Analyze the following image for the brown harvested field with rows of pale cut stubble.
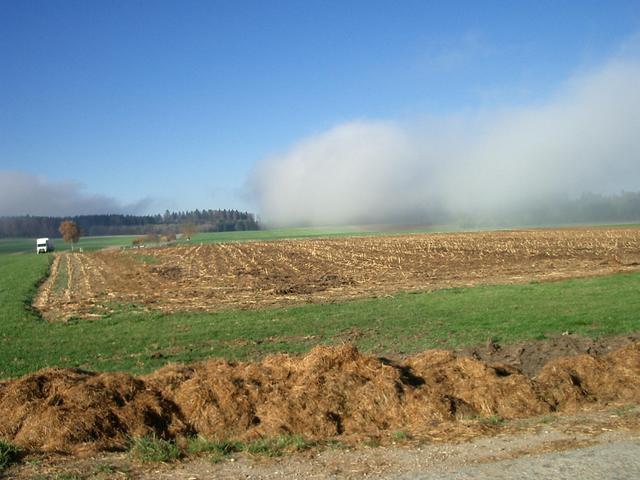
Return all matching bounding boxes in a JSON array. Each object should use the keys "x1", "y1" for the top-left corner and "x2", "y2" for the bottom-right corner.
[{"x1": 34, "y1": 228, "x2": 640, "y2": 321}]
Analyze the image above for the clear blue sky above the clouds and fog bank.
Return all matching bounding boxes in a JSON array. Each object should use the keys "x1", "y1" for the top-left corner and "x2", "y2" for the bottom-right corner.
[{"x1": 0, "y1": 0, "x2": 640, "y2": 218}]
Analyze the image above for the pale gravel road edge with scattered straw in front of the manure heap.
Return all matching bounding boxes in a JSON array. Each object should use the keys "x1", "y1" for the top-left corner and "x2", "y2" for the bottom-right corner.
[{"x1": 8, "y1": 405, "x2": 640, "y2": 480}]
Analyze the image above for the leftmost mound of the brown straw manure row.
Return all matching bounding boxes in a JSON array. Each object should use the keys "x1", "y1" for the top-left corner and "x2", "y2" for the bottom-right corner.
[{"x1": 0, "y1": 368, "x2": 188, "y2": 451}]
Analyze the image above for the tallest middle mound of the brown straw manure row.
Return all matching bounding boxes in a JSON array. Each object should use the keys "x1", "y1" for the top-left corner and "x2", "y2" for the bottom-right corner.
[{"x1": 147, "y1": 345, "x2": 404, "y2": 438}]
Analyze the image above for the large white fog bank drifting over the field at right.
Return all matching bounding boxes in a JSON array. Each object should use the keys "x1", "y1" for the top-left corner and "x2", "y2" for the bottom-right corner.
[{"x1": 250, "y1": 59, "x2": 640, "y2": 225}]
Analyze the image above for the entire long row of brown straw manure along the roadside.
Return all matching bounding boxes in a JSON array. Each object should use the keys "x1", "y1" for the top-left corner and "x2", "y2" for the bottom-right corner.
[{"x1": 0, "y1": 342, "x2": 640, "y2": 452}]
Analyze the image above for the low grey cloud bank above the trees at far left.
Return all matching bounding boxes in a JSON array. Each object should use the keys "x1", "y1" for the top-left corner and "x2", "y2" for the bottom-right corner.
[{"x1": 0, "y1": 170, "x2": 151, "y2": 217}]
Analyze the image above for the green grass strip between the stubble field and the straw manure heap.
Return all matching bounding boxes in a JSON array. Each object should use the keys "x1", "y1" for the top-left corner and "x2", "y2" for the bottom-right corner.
[{"x1": 0, "y1": 233, "x2": 640, "y2": 378}]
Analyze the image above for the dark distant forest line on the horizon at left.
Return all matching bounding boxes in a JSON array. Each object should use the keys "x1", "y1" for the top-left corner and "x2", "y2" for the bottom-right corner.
[{"x1": 0, "y1": 209, "x2": 260, "y2": 238}]
